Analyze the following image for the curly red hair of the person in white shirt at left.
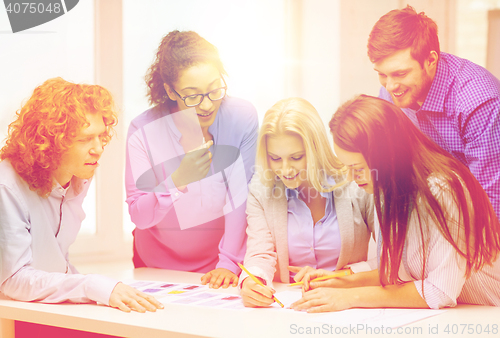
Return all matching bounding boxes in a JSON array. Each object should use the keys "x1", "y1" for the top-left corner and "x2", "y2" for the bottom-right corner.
[{"x1": 0, "y1": 77, "x2": 118, "y2": 196}]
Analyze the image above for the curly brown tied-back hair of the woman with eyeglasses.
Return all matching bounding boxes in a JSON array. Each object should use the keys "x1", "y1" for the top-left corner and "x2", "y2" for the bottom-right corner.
[{"x1": 146, "y1": 30, "x2": 227, "y2": 105}]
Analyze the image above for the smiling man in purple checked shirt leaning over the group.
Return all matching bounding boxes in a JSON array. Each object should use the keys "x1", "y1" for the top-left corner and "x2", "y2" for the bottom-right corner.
[{"x1": 368, "y1": 6, "x2": 500, "y2": 222}]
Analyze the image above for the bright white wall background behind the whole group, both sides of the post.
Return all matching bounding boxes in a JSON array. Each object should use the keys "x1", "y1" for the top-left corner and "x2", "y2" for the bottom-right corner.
[{"x1": 0, "y1": 0, "x2": 500, "y2": 264}]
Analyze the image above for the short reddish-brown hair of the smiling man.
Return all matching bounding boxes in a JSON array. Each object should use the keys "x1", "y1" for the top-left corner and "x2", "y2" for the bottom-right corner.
[{"x1": 368, "y1": 5, "x2": 440, "y2": 67}]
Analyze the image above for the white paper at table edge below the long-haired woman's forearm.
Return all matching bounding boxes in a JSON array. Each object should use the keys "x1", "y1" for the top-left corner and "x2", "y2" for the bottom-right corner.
[{"x1": 311, "y1": 309, "x2": 447, "y2": 328}]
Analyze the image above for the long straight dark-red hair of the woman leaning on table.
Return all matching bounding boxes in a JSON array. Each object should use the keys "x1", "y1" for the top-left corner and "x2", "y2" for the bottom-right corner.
[{"x1": 329, "y1": 95, "x2": 500, "y2": 285}]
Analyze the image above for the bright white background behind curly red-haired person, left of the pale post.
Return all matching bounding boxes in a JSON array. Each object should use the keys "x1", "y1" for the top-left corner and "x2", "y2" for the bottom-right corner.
[{"x1": 0, "y1": 1, "x2": 95, "y2": 233}]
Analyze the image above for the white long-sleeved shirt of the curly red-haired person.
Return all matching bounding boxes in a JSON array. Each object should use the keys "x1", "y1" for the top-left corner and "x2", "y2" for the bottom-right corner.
[{"x1": 0, "y1": 160, "x2": 118, "y2": 305}]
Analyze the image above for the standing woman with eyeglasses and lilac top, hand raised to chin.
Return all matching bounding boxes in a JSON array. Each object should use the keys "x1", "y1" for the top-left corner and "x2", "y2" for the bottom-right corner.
[{"x1": 125, "y1": 31, "x2": 258, "y2": 288}]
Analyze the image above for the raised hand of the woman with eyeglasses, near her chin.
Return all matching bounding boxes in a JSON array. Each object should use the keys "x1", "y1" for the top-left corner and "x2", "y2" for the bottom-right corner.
[{"x1": 172, "y1": 140, "x2": 214, "y2": 189}]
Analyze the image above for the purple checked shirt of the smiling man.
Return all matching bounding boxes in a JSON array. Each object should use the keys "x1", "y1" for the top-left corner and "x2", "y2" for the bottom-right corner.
[{"x1": 379, "y1": 53, "x2": 500, "y2": 219}]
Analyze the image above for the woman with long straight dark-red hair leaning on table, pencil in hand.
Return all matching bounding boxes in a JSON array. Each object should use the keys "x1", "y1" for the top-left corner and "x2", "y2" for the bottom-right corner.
[{"x1": 294, "y1": 95, "x2": 500, "y2": 312}]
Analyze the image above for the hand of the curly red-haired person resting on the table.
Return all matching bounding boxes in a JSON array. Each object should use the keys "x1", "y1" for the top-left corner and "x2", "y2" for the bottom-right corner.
[{"x1": 109, "y1": 282, "x2": 163, "y2": 312}]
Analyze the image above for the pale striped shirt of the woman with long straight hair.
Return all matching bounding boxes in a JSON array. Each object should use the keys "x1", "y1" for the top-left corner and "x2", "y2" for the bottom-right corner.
[{"x1": 399, "y1": 179, "x2": 500, "y2": 309}]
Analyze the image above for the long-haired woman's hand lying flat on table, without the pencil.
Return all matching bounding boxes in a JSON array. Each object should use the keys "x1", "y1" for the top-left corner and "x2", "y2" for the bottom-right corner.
[{"x1": 290, "y1": 288, "x2": 356, "y2": 313}]
